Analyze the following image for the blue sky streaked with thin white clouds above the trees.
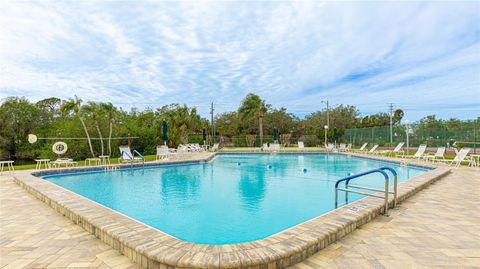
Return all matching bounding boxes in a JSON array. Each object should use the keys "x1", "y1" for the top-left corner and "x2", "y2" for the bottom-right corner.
[{"x1": 0, "y1": 1, "x2": 480, "y2": 120}]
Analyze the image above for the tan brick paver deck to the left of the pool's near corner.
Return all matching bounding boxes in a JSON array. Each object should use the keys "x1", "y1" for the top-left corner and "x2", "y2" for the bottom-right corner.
[{"x1": 0, "y1": 176, "x2": 139, "y2": 269}]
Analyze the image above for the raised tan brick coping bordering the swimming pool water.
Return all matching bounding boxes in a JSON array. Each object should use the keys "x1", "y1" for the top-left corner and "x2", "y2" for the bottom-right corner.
[{"x1": 14, "y1": 153, "x2": 450, "y2": 268}]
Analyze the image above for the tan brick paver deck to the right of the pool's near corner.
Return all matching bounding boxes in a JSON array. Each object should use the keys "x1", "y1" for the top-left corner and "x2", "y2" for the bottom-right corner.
[{"x1": 291, "y1": 168, "x2": 480, "y2": 269}]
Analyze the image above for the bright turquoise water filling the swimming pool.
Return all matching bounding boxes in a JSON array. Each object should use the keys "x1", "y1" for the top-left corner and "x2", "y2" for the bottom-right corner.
[{"x1": 45, "y1": 154, "x2": 426, "y2": 244}]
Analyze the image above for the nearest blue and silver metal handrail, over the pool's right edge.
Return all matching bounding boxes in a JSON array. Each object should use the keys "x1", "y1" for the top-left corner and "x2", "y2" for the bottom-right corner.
[{"x1": 335, "y1": 167, "x2": 396, "y2": 214}]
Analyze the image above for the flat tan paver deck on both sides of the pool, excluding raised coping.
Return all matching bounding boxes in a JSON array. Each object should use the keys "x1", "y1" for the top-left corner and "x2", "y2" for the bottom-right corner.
[{"x1": 0, "y1": 162, "x2": 480, "y2": 269}]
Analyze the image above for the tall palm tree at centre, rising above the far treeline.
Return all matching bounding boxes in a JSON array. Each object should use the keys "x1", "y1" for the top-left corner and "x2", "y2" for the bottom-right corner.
[{"x1": 238, "y1": 93, "x2": 269, "y2": 145}]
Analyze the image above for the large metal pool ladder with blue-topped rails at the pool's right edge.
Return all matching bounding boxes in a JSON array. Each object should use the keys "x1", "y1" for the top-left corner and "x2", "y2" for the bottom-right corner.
[{"x1": 335, "y1": 166, "x2": 398, "y2": 215}]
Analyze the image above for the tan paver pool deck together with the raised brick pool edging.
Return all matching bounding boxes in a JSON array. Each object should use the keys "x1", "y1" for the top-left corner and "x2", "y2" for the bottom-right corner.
[{"x1": 0, "y1": 152, "x2": 480, "y2": 268}]
